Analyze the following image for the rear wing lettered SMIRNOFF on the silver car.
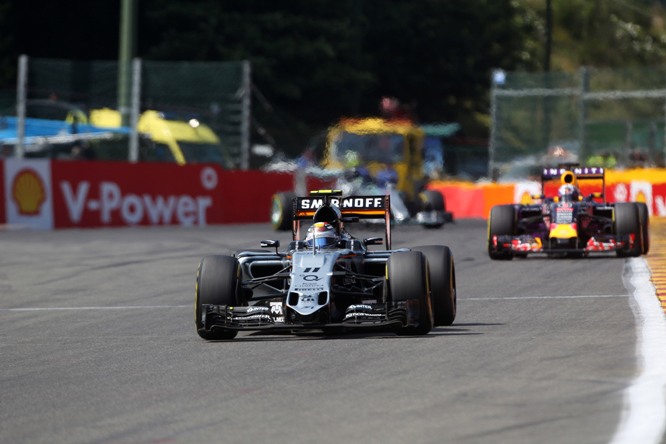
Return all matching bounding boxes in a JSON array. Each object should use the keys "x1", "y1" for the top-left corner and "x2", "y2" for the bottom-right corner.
[{"x1": 292, "y1": 190, "x2": 391, "y2": 250}]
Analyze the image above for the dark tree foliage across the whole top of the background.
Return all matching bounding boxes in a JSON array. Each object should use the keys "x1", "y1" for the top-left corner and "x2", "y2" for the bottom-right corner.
[{"x1": 0, "y1": 0, "x2": 666, "y2": 143}]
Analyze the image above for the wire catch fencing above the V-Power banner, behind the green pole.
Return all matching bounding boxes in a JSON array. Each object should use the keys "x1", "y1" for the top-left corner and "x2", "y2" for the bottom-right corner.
[{"x1": 11, "y1": 56, "x2": 252, "y2": 169}]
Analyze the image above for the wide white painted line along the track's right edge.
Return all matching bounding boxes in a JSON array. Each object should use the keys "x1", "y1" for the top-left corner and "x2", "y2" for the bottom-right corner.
[{"x1": 610, "y1": 258, "x2": 666, "y2": 444}]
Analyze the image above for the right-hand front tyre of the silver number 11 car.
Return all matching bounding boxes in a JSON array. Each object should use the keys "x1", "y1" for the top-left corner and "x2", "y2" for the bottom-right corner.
[{"x1": 387, "y1": 251, "x2": 434, "y2": 335}]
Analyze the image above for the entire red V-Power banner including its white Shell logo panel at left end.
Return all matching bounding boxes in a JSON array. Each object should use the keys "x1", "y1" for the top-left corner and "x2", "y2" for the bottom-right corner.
[{"x1": 0, "y1": 159, "x2": 293, "y2": 229}]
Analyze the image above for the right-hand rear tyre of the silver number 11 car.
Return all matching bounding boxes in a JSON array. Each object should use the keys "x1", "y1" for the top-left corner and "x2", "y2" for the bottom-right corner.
[{"x1": 412, "y1": 245, "x2": 457, "y2": 326}]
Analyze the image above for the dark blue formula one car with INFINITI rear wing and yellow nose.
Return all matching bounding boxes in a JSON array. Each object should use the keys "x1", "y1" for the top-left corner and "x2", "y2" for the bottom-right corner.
[{"x1": 488, "y1": 165, "x2": 650, "y2": 260}]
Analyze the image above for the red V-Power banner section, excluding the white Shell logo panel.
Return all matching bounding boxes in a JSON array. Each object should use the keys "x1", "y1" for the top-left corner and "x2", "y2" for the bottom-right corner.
[{"x1": 52, "y1": 161, "x2": 293, "y2": 228}]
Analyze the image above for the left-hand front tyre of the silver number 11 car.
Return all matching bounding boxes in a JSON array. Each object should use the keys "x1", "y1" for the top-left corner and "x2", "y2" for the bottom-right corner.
[{"x1": 194, "y1": 256, "x2": 239, "y2": 340}]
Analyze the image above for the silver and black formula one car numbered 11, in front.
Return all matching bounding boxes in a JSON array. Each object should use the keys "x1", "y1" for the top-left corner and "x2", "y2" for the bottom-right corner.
[{"x1": 195, "y1": 190, "x2": 456, "y2": 340}]
